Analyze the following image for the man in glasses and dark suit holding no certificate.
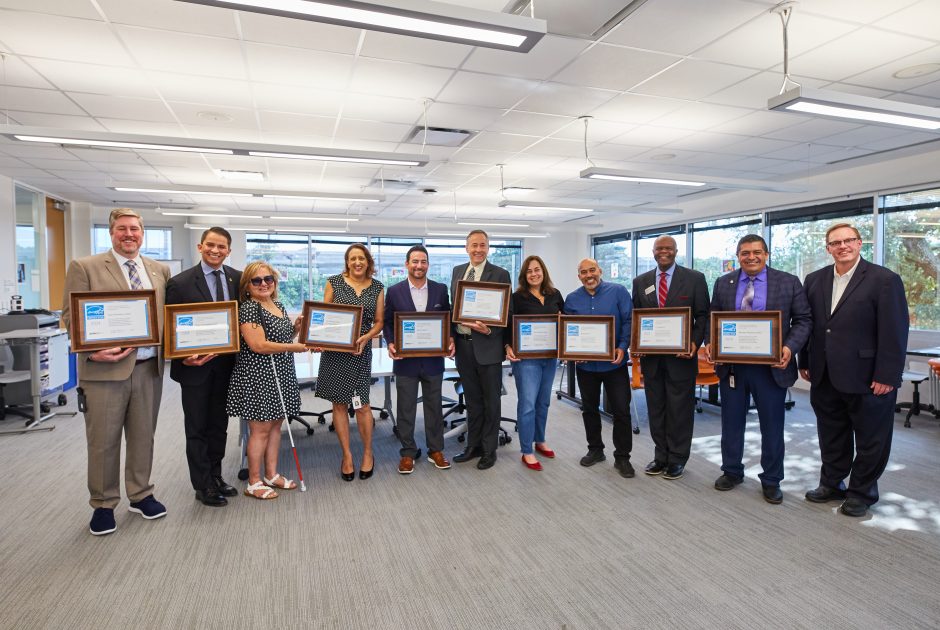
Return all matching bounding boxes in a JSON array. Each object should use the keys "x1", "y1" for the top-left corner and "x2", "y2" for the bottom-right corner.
[{"x1": 799, "y1": 223, "x2": 910, "y2": 517}]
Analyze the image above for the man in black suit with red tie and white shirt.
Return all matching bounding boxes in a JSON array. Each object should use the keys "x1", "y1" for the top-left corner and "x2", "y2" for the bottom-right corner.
[{"x1": 632, "y1": 236, "x2": 708, "y2": 479}]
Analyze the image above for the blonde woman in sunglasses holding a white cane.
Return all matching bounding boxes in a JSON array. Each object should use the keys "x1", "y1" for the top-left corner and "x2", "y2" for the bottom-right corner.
[{"x1": 228, "y1": 261, "x2": 307, "y2": 499}]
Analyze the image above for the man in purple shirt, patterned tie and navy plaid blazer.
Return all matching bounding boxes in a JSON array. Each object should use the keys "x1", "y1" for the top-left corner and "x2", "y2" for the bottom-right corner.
[{"x1": 706, "y1": 234, "x2": 813, "y2": 504}]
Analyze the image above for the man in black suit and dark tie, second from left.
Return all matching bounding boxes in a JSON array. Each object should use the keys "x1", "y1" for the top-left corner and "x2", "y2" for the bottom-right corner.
[{"x1": 166, "y1": 227, "x2": 242, "y2": 507}]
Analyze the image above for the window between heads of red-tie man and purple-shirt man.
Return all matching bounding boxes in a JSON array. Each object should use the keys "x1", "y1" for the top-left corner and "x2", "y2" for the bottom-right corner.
[{"x1": 691, "y1": 214, "x2": 761, "y2": 292}]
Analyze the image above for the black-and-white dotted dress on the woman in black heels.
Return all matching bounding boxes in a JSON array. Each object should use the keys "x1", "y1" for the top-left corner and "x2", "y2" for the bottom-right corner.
[{"x1": 317, "y1": 275, "x2": 385, "y2": 405}]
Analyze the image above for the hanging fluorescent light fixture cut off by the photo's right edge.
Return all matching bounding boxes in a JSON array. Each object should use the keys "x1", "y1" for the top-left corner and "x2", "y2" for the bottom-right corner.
[{"x1": 767, "y1": 86, "x2": 940, "y2": 131}]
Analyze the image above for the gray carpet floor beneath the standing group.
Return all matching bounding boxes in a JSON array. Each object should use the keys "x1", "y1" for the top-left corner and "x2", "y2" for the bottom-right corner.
[{"x1": 0, "y1": 370, "x2": 940, "y2": 629}]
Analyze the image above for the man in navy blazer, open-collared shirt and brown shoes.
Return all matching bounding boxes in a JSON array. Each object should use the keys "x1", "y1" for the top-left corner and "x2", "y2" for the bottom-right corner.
[{"x1": 384, "y1": 245, "x2": 454, "y2": 475}]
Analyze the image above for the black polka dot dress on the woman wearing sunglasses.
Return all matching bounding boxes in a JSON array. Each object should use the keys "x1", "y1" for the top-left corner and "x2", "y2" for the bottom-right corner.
[{"x1": 226, "y1": 300, "x2": 300, "y2": 422}]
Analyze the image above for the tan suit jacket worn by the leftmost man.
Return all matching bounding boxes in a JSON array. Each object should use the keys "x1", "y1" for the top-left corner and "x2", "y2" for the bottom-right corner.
[{"x1": 62, "y1": 250, "x2": 170, "y2": 381}]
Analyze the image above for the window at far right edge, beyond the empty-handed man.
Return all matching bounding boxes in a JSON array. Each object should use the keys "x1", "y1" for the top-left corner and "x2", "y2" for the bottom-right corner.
[{"x1": 880, "y1": 189, "x2": 940, "y2": 330}]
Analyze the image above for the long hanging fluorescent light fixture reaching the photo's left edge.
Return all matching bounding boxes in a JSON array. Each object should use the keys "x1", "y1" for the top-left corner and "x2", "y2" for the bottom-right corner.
[{"x1": 0, "y1": 125, "x2": 431, "y2": 166}]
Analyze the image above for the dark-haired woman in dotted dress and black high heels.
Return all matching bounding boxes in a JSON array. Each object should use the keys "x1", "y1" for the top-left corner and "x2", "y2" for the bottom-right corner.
[{"x1": 317, "y1": 243, "x2": 385, "y2": 481}]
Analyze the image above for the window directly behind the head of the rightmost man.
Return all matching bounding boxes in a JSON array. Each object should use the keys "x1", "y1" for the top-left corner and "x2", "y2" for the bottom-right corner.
[{"x1": 767, "y1": 197, "x2": 875, "y2": 281}]
